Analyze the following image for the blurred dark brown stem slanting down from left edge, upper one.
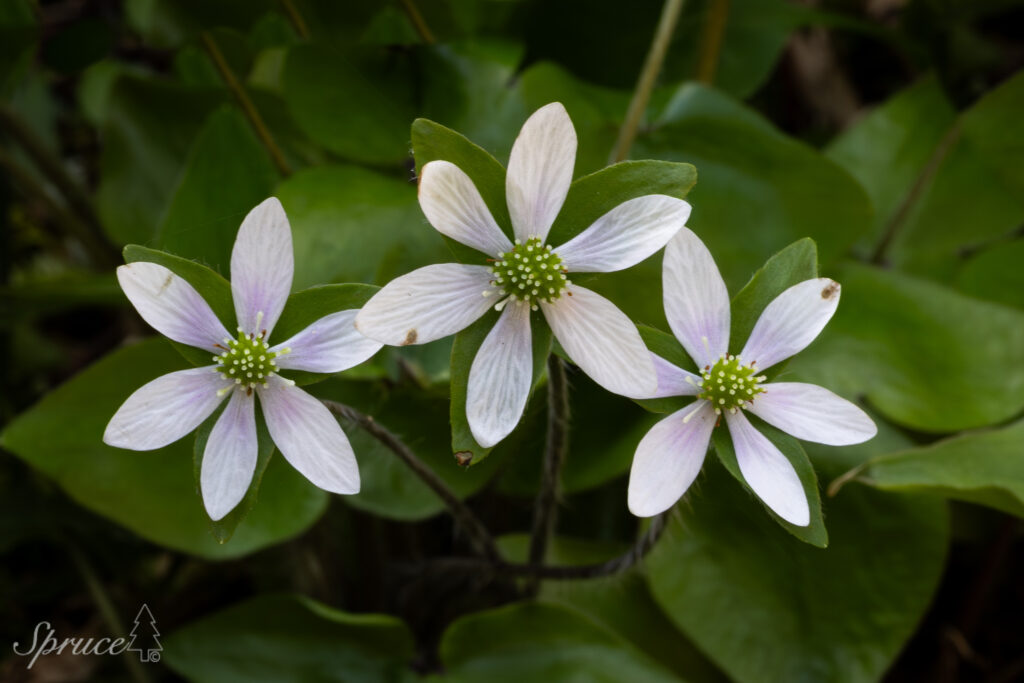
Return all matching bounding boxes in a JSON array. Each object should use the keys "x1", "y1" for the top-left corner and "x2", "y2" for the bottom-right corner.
[{"x1": 0, "y1": 105, "x2": 121, "y2": 265}]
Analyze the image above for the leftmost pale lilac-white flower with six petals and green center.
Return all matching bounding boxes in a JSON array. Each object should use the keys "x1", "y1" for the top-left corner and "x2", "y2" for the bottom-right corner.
[{"x1": 103, "y1": 198, "x2": 381, "y2": 520}]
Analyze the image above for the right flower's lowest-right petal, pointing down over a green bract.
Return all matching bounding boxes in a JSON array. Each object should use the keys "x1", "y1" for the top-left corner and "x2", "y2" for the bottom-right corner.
[{"x1": 725, "y1": 411, "x2": 811, "y2": 526}]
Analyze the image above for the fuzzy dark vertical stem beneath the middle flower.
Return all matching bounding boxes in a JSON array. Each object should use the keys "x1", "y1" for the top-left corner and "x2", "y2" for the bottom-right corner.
[{"x1": 526, "y1": 355, "x2": 569, "y2": 593}]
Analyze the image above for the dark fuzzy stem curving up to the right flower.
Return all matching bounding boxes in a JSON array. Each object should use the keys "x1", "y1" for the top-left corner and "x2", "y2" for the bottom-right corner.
[{"x1": 431, "y1": 513, "x2": 667, "y2": 581}]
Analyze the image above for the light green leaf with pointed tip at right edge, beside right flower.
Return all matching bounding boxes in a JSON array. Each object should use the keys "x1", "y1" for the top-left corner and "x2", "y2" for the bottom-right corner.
[{"x1": 859, "y1": 420, "x2": 1024, "y2": 517}]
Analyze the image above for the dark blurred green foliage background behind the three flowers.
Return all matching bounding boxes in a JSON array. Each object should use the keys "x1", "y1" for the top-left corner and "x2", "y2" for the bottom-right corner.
[{"x1": 0, "y1": 0, "x2": 1024, "y2": 683}]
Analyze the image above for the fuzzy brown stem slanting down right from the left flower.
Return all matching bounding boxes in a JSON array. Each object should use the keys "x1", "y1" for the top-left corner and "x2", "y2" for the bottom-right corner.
[{"x1": 324, "y1": 399, "x2": 501, "y2": 562}]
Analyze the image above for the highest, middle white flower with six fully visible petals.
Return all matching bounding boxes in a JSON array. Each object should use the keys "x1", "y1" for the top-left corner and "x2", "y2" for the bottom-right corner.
[{"x1": 355, "y1": 102, "x2": 690, "y2": 447}]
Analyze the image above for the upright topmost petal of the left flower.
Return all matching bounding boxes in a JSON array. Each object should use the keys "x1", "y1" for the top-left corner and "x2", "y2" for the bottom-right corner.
[{"x1": 231, "y1": 197, "x2": 295, "y2": 337}]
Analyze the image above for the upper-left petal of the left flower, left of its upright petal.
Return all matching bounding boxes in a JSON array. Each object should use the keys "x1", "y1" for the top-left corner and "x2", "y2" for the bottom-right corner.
[{"x1": 118, "y1": 261, "x2": 234, "y2": 352}]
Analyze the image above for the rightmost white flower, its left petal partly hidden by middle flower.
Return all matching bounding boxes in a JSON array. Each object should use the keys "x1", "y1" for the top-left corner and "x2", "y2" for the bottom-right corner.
[{"x1": 629, "y1": 228, "x2": 877, "y2": 526}]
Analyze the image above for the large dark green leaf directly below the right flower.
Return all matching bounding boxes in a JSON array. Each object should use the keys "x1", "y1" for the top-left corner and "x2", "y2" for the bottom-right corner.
[{"x1": 646, "y1": 462, "x2": 948, "y2": 683}]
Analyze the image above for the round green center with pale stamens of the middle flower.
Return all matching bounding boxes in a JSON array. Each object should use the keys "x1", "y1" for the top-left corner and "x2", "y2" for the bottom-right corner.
[{"x1": 484, "y1": 238, "x2": 570, "y2": 307}]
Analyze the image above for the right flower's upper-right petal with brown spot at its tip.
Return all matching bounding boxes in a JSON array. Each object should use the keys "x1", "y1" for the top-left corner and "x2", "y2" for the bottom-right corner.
[{"x1": 739, "y1": 278, "x2": 840, "y2": 370}]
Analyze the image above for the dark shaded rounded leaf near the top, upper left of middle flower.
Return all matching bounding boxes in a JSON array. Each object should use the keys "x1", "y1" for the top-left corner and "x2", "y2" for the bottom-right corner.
[{"x1": 284, "y1": 44, "x2": 416, "y2": 164}]
